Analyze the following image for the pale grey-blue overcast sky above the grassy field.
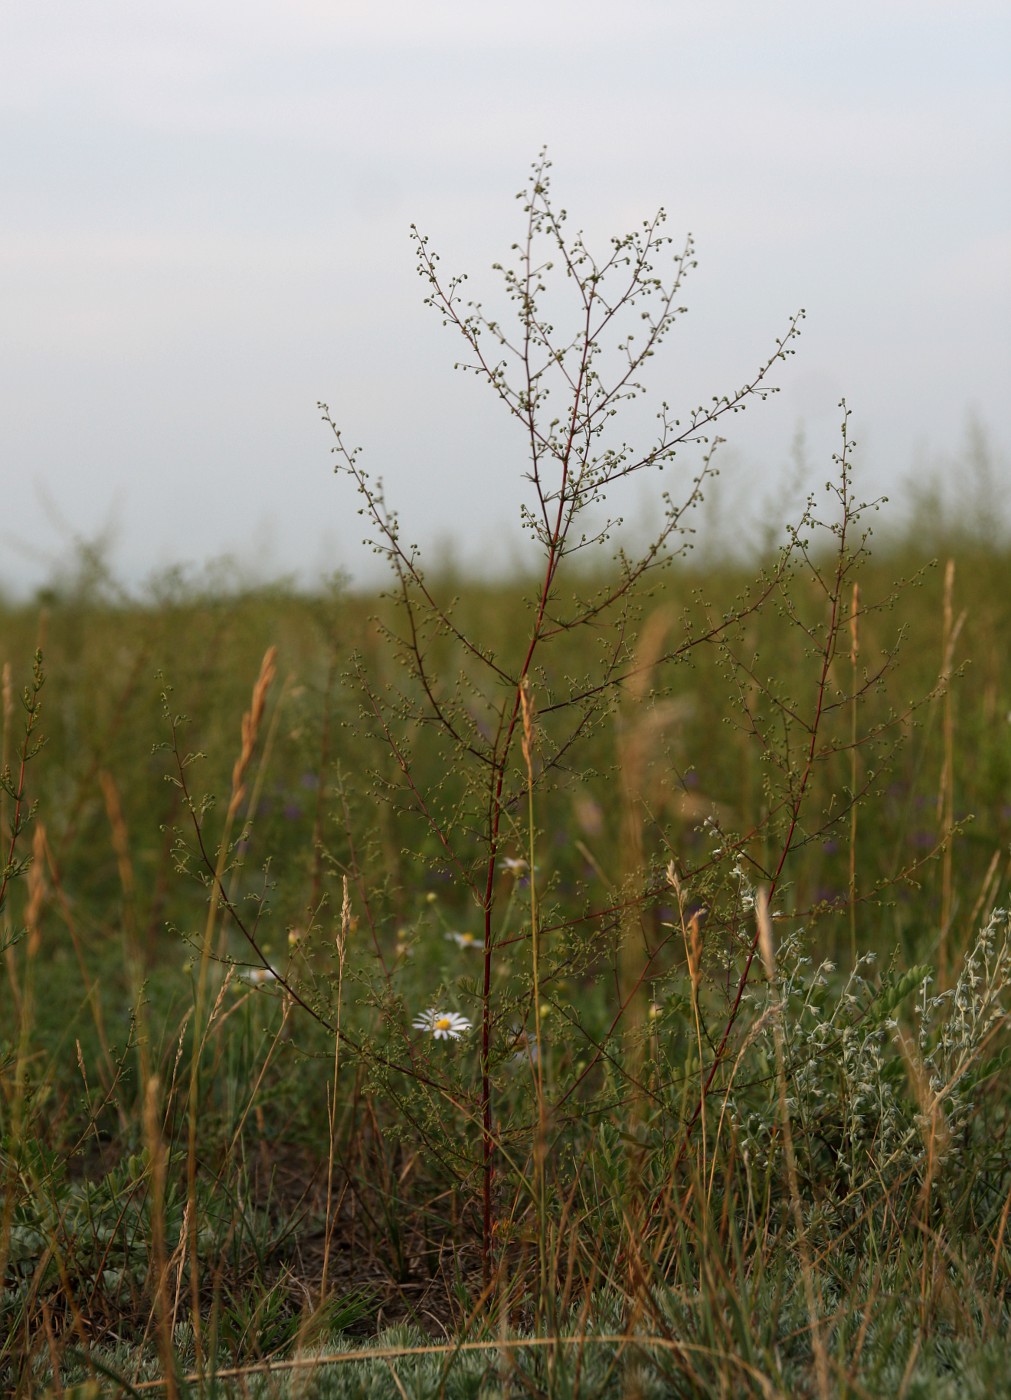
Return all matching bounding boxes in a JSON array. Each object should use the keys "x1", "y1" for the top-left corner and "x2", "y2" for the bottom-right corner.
[{"x1": 0, "y1": 0, "x2": 1011, "y2": 592}]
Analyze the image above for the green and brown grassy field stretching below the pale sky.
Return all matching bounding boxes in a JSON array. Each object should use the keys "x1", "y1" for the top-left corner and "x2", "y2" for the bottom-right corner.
[{"x1": 0, "y1": 515, "x2": 1011, "y2": 1397}]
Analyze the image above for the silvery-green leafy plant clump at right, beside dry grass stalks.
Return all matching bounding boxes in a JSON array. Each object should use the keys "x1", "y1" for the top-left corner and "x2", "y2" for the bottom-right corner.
[{"x1": 731, "y1": 909, "x2": 1011, "y2": 1214}]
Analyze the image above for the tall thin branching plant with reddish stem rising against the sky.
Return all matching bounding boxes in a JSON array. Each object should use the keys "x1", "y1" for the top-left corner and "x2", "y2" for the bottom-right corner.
[{"x1": 321, "y1": 154, "x2": 896, "y2": 1275}]
